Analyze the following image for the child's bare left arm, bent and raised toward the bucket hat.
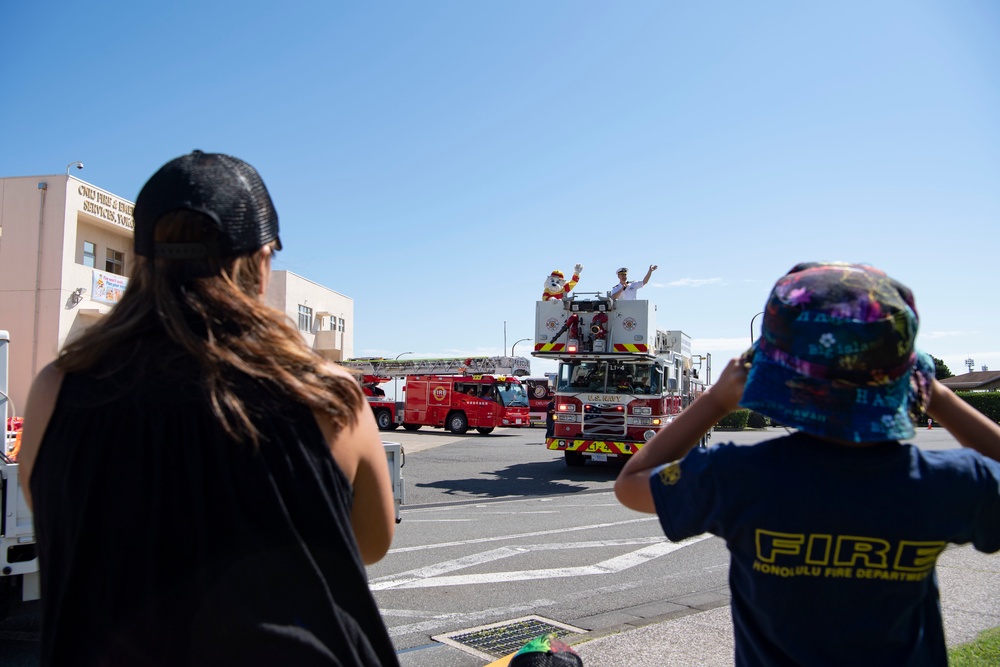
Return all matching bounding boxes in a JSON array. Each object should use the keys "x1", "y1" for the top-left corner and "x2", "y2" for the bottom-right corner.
[{"x1": 615, "y1": 358, "x2": 747, "y2": 513}]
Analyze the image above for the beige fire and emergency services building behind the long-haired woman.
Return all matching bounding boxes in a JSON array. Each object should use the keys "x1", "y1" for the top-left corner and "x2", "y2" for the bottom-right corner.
[{"x1": 0, "y1": 174, "x2": 354, "y2": 413}]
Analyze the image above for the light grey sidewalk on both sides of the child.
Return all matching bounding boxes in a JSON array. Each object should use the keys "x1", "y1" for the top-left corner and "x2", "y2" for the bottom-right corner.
[{"x1": 574, "y1": 546, "x2": 1000, "y2": 667}]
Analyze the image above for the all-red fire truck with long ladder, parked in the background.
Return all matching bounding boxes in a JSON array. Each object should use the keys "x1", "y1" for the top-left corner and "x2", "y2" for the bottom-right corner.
[{"x1": 340, "y1": 357, "x2": 531, "y2": 435}]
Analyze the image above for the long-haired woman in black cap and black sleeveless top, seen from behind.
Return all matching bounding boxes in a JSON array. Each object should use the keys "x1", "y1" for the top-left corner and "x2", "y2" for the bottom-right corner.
[{"x1": 19, "y1": 151, "x2": 398, "y2": 666}]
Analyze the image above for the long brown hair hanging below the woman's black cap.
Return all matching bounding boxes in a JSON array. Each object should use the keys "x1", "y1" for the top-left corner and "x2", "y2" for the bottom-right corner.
[{"x1": 56, "y1": 211, "x2": 364, "y2": 444}]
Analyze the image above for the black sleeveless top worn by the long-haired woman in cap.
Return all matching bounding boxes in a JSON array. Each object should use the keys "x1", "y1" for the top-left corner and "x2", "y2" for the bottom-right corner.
[{"x1": 31, "y1": 355, "x2": 398, "y2": 667}]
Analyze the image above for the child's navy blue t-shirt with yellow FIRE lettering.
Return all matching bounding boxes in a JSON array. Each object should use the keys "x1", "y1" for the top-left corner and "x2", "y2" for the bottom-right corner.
[{"x1": 650, "y1": 433, "x2": 1000, "y2": 667}]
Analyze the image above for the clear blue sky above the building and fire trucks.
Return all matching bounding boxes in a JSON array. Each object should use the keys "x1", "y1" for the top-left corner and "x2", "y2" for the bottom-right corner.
[{"x1": 0, "y1": 0, "x2": 1000, "y2": 374}]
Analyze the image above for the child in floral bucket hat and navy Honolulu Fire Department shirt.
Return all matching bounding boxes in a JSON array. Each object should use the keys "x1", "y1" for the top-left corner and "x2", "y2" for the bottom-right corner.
[{"x1": 615, "y1": 262, "x2": 1000, "y2": 667}]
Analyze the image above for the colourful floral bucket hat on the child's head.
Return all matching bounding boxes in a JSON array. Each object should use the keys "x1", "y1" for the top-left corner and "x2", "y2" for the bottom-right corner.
[{"x1": 740, "y1": 262, "x2": 934, "y2": 442}]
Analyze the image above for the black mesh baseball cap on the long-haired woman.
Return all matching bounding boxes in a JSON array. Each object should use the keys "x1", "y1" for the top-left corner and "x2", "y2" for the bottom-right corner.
[{"x1": 133, "y1": 151, "x2": 281, "y2": 259}]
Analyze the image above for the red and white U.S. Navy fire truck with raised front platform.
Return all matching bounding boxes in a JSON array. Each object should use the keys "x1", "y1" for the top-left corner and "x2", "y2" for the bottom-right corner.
[{"x1": 532, "y1": 293, "x2": 711, "y2": 466}]
